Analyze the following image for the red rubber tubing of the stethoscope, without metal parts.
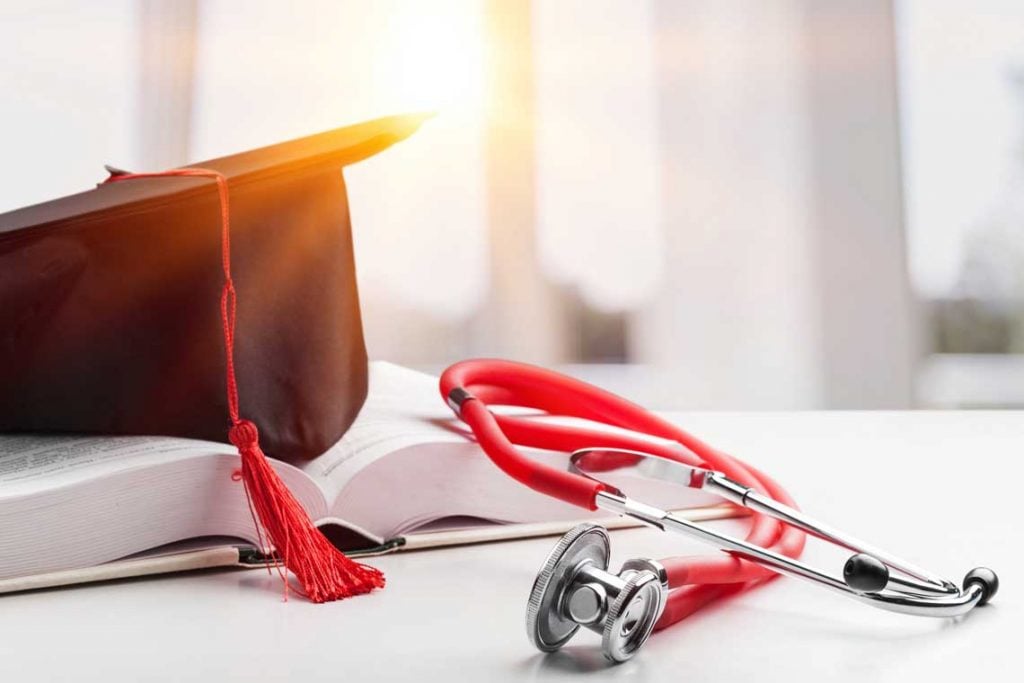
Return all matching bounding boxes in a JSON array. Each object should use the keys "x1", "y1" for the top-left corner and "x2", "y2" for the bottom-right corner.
[{"x1": 440, "y1": 359, "x2": 806, "y2": 629}]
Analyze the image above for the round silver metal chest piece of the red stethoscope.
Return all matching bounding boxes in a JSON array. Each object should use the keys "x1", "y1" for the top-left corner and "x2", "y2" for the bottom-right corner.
[{"x1": 526, "y1": 524, "x2": 668, "y2": 661}]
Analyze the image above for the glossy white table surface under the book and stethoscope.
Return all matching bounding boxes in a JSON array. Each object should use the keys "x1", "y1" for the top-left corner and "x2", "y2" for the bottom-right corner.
[{"x1": 0, "y1": 412, "x2": 1024, "y2": 683}]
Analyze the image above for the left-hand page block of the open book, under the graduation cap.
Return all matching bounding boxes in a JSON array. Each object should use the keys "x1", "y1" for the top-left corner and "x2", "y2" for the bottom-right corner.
[{"x1": 0, "y1": 435, "x2": 328, "y2": 580}]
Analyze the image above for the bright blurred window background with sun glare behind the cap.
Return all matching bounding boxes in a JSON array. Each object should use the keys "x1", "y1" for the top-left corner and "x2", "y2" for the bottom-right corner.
[{"x1": 0, "y1": 0, "x2": 1024, "y2": 409}]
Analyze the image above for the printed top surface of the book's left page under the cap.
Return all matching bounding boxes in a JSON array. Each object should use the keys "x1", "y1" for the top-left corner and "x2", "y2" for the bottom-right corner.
[{"x1": 0, "y1": 434, "x2": 236, "y2": 496}]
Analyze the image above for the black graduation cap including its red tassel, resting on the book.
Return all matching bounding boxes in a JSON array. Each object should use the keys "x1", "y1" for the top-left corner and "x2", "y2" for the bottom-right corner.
[{"x1": 0, "y1": 116, "x2": 426, "y2": 602}]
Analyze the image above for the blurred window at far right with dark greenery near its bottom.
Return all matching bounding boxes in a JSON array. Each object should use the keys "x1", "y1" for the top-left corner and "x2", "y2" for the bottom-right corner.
[{"x1": 897, "y1": 0, "x2": 1024, "y2": 405}]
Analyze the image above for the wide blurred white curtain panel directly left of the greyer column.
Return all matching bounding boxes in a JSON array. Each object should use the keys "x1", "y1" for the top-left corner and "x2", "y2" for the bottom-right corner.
[{"x1": 633, "y1": 0, "x2": 822, "y2": 408}]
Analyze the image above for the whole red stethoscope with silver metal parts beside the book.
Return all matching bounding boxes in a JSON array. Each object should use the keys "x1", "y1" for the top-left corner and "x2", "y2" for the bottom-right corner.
[{"x1": 440, "y1": 359, "x2": 998, "y2": 661}]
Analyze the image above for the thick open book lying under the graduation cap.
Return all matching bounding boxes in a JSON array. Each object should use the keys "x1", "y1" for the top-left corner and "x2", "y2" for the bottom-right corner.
[{"x1": 0, "y1": 362, "x2": 732, "y2": 592}]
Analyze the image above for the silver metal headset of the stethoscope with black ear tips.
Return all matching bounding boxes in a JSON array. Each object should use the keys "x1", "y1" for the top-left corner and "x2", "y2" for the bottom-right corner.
[{"x1": 569, "y1": 449, "x2": 997, "y2": 616}]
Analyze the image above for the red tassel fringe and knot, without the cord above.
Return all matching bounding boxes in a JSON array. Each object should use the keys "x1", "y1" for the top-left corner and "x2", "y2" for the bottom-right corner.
[{"x1": 228, "y1": 420, "x2": 384, "y2": 602}]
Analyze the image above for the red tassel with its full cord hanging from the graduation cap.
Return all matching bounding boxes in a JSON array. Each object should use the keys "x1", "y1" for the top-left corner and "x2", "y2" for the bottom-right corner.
[{"x1": 106, "y1": 168, "x2": 384, "y2": 602}]
